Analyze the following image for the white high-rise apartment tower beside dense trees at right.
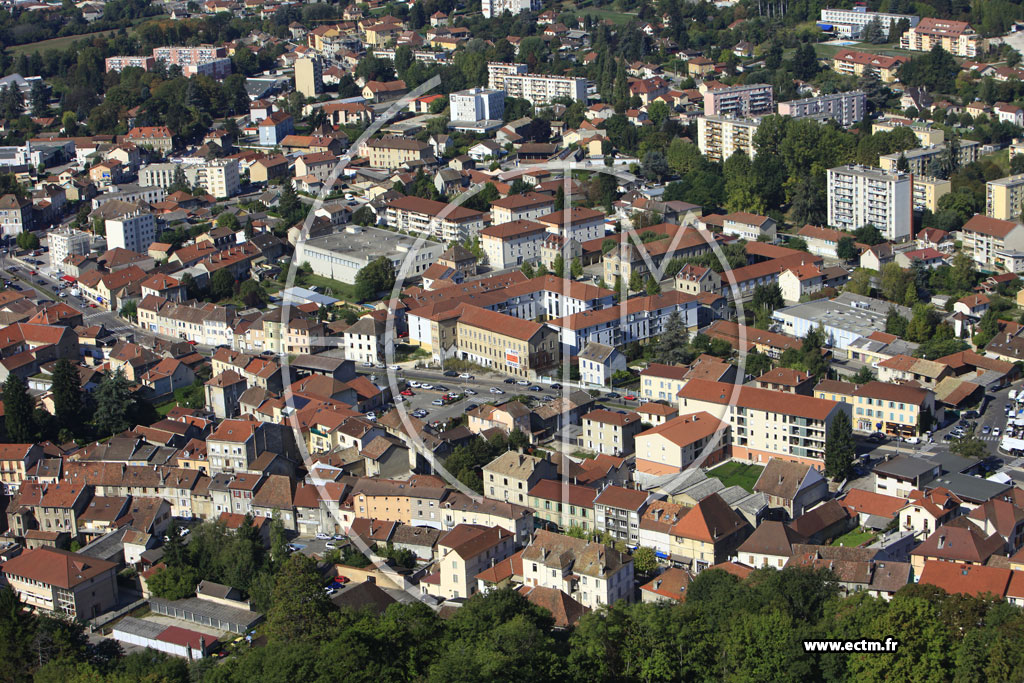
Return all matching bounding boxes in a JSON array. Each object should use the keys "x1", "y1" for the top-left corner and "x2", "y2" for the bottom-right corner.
[{"x1": 827, "y1": 164, "x2": 913, "y2": 242}]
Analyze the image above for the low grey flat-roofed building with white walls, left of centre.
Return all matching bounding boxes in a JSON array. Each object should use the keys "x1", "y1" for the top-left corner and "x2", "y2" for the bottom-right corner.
[{"x1": 295, "y1": 225, "x2": 444, "y2": 285}]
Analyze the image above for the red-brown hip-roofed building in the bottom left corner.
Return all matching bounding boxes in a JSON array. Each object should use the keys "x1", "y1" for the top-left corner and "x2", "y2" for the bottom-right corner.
[{"x1": 2, "y1": 548, "x2": 118, "y2": 620}]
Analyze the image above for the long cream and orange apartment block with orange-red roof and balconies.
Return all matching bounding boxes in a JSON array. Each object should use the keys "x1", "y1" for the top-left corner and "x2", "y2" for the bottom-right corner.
[{"x1": 679, "y1": 379, "x2": 850, "y2": 470}]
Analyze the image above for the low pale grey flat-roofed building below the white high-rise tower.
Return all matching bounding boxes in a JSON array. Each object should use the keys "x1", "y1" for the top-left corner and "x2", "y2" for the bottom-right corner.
[{"x1": 772, "y1": 292, "x2": 912, "y2": 354}]
